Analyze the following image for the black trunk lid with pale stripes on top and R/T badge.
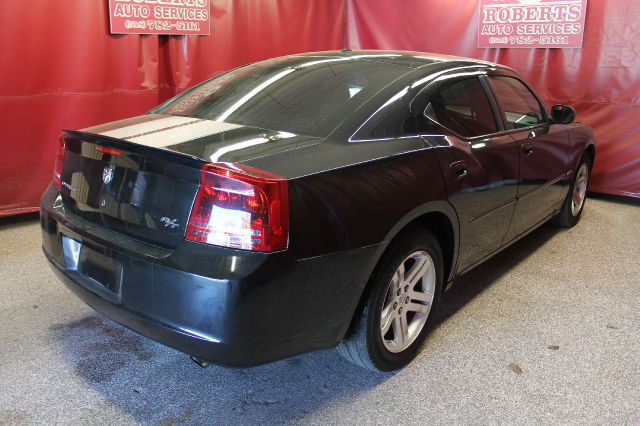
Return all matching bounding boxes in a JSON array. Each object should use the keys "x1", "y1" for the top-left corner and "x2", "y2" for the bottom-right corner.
[{"x1": 61, "y1": 114, "x2": 319, "y2": 248}]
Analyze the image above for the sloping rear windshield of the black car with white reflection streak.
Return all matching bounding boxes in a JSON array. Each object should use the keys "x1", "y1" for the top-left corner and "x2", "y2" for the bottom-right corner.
[{"x1": 152, "y1": 57, "x2": 409, "y2": 137}]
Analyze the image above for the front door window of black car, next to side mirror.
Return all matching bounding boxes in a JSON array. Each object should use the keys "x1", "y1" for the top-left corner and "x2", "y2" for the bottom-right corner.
[{"x1": 490, "y1": 76, "x2": 545, "y2": 130}]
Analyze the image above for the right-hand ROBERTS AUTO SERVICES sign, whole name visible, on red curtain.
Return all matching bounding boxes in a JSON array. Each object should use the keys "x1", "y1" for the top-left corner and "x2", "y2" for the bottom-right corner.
[{"x1": 478, "y1": 0, "x2": 587, "y2": 48}]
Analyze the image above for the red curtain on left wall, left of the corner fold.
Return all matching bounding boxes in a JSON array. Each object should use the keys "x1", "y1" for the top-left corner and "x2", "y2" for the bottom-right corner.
[{"x1": 0, "y1": 0, "x2": 345, "y2": 217}]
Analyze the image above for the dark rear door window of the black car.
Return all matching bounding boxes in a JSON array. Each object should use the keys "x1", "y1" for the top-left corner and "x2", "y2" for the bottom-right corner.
[{"x1": 424, "y1": 77, "x2": 498, "y2": 138}]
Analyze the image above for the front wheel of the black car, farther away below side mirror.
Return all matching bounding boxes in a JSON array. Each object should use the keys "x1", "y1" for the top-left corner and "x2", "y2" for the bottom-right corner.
[{"x1": 552, "y1": 152, "x2": 592, "y2": 228}]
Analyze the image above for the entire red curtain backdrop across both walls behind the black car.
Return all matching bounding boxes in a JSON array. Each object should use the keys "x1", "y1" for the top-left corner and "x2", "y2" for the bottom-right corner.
[{"x1": 0, "y1": 0, "x2": 640, "y2": 216}]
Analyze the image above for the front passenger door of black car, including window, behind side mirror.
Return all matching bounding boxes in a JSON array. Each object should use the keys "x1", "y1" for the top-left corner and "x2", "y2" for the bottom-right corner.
[{"x1": 488, "y1": 75, "x2": 569, "y2": 243}]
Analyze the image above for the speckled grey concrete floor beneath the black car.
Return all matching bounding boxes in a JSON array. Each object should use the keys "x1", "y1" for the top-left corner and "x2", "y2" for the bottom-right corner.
[{"x1": 0, "y1": 197, "x2": 640, "y2": 425}]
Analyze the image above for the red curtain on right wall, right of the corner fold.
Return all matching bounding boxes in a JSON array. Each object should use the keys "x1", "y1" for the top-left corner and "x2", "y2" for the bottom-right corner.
[{"x1": 347, "y1": 0, "x2": 640, "y2": 197}]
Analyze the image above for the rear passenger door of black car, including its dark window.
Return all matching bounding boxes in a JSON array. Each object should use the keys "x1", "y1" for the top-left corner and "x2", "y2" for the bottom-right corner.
[{"x1": 412, "y1": 73, "x2": 518, "y2": 271}]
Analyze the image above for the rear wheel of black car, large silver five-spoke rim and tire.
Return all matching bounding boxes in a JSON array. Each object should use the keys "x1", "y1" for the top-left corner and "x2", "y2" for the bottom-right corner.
[{"x1": 337, "y1": 228, "x2": 443, "y2": 371}]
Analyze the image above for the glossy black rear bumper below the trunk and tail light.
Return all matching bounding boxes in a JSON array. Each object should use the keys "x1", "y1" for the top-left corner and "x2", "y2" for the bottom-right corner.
[{"x1": 41, "y1": 187, "x2": 384, "y2": 367}]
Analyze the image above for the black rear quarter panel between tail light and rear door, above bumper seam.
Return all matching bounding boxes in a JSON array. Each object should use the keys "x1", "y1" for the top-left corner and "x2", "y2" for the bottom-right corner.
[{"x1": 241, "y1": 137, "x2": 446, "y2": 258}]
